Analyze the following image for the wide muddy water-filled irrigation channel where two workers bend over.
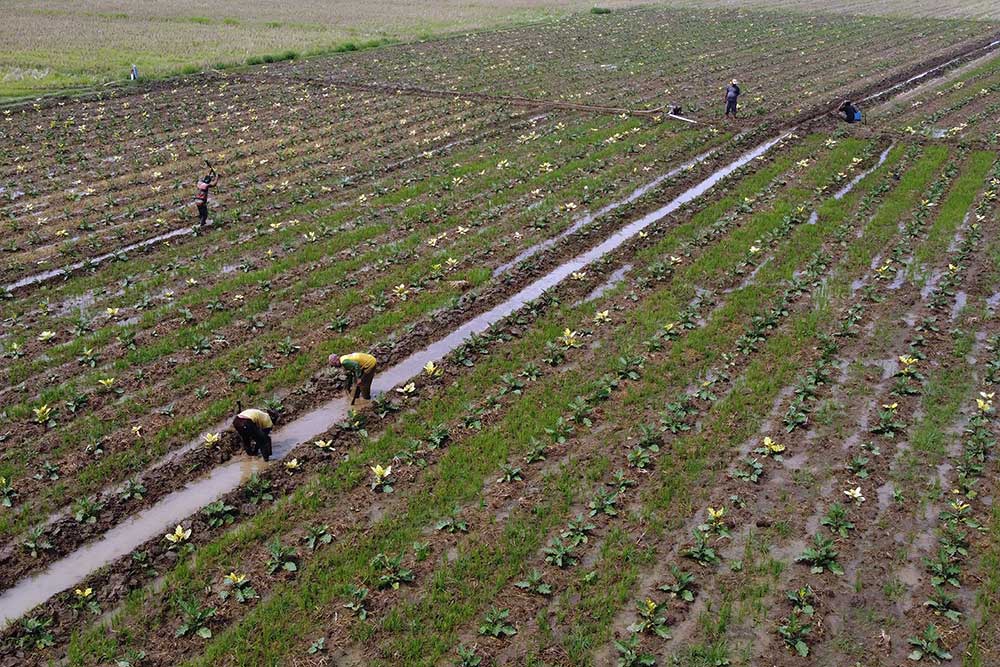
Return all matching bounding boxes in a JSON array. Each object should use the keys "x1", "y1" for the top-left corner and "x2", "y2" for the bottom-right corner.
[{"x1": 0, "y1": 130, "x2": 792, "y2": 630}]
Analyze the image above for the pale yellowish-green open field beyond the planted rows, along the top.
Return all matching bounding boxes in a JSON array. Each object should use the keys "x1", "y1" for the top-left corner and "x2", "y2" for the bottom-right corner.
[{"x1": 0, "y1": 0, "x2": 1000, "y2": 100}]
